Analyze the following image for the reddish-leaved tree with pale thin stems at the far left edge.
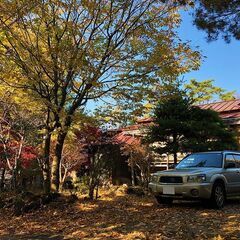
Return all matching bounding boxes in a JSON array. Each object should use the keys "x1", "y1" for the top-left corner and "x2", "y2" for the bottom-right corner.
[{"x1": 0, "y1": 92, "x2": 40, "y2": 189}]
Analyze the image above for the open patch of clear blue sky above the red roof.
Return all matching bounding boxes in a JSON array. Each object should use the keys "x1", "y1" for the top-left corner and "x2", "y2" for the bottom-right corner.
[{"x1": 179, "y1": 12, "x2": 240, "y2": 95}]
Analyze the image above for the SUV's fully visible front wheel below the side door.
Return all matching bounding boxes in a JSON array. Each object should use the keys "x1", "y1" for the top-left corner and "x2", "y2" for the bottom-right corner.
[{"x1": 211, "y1": 183, "x2": 226, "y2": 209}]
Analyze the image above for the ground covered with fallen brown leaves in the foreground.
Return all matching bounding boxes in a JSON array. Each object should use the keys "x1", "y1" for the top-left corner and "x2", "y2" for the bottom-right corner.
[{"x1": 0, "y1": 189, "x2": 240, "y2": 240}]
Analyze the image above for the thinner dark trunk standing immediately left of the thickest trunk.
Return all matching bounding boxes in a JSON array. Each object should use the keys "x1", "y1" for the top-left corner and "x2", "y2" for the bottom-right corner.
[{"x1": 43, "y1": 133, "x2": 51, "y2": 194}]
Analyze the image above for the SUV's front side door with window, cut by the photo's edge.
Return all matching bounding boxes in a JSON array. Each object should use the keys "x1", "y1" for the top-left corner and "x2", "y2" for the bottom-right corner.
[{"x1": 223, "y1": 154, "x2": 240, "y2": 195}]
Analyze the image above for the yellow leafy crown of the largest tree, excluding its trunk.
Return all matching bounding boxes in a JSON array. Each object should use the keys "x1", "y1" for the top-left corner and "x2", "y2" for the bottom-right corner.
[{"x1": 0, "y1": 0, "x2": 203, "y2": 139}]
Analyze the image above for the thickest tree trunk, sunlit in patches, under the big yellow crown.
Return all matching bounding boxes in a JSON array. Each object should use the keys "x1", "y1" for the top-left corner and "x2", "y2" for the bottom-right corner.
[{"x1": 51, "y1": 132, "x2": 67, "y2": 192}]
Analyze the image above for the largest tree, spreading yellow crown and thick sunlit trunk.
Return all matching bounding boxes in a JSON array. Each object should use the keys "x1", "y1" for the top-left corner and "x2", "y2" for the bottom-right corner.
[{"x1": 0, "y1": 0, "x2": 199, "y2": 191}]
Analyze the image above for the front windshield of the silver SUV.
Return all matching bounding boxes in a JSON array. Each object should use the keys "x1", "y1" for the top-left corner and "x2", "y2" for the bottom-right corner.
[{"x1": 176, "y1": 153, "x2": 223, "y2": 169}]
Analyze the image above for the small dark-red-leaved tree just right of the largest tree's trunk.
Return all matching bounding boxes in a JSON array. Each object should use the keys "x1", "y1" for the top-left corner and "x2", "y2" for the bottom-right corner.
[{"x1": 75, "y1": 124, "x2": 116, "y2": 199}]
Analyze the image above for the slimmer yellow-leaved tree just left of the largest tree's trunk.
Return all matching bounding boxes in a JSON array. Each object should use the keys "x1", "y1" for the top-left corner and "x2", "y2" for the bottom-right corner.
[{"x1": 0, "y1": 83, "x2": 52, "y2": 193}]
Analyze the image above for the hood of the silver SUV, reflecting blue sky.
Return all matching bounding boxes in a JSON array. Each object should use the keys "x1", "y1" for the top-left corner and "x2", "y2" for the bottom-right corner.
[{"x1": 157, "y1": 168, "x2": 220, "y2": 176}]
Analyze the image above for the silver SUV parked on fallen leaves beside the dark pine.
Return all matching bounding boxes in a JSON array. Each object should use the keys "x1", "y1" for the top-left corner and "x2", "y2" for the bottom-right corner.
[{"x1": 149, "y1": 151, "x2": 240, "y2": 208}]
